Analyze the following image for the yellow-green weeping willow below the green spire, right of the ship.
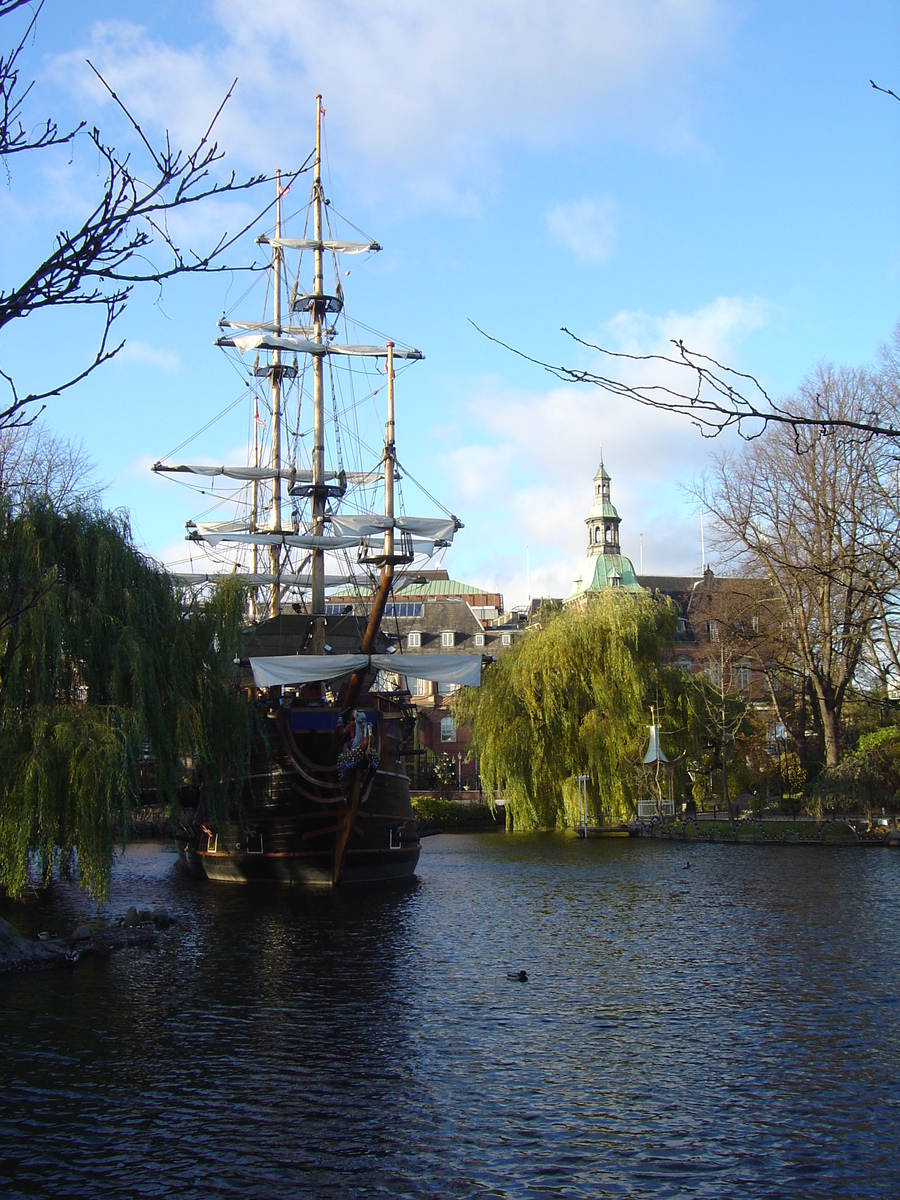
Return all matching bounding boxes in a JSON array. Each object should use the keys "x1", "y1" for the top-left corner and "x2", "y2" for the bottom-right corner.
[{"x1": 456, "y1": 590, "x2": 694, "y2": 829}]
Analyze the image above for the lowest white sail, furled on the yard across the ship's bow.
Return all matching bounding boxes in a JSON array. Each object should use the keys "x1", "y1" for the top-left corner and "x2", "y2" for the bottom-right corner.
[{"x1": 250, "y1": 654, "x2": 481, "y2": 688}]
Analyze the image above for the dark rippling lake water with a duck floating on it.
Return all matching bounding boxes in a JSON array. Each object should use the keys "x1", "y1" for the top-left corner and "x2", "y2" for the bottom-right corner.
[{"x1": 0, "y1": 834, "x2": 900, "y2": 1200}]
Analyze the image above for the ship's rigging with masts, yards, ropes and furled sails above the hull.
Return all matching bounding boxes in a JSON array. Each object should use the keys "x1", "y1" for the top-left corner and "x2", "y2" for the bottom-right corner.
[{"x1": 154, "y1": 97, "x2": 461, "y2": 628}]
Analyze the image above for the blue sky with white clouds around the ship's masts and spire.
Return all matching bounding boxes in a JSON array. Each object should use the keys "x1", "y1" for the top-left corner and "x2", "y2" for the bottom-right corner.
[{"x1": 0, "y1": 0, "x2": 900, "y2": 605}]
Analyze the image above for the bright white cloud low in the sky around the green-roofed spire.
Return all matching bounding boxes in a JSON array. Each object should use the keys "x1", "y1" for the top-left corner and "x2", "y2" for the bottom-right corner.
[{"x1": 442, "y1": 298, "x2": 764, "y2": 605}]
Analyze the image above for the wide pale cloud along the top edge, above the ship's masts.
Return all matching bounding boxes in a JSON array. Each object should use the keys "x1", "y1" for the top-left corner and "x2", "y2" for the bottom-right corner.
[{"x1": 53, "y1": 0, "x2": 731, "y2": 204}]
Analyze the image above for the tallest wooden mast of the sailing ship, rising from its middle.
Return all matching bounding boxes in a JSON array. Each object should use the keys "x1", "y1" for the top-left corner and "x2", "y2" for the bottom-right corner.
[{"x1": 311, "y1": 95, "x2": 326, "y2": 654}]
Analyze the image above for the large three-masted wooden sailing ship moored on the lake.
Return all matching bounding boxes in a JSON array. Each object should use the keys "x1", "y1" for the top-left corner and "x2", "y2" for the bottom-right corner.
[{"x1": 154, "y1": 96, "x2": 481, "y2": 886}]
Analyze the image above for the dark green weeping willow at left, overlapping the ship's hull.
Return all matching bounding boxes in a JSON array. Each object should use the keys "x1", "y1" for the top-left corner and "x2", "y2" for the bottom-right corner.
[{"x1": 0, "y1": 500, "x2": 251, "y2": 896}]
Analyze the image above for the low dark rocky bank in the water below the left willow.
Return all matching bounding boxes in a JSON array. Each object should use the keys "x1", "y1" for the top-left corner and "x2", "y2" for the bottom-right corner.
[{"x1": 0, "y1": 906, "x2": 178, "y2": 972}]
